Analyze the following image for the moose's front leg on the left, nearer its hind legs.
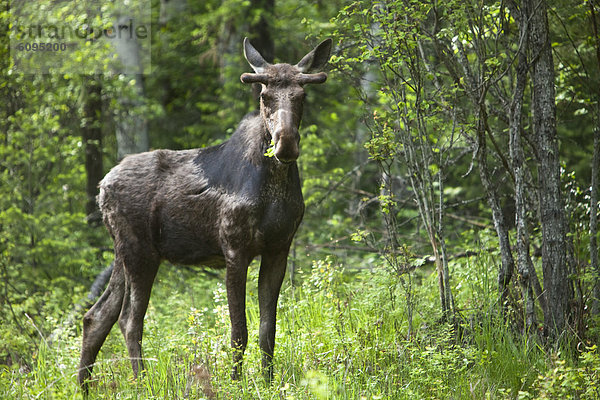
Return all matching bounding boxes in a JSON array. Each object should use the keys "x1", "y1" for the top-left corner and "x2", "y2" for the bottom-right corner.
[{"x1": 225, "y1": 257, "x2": 249, "y2": 380}]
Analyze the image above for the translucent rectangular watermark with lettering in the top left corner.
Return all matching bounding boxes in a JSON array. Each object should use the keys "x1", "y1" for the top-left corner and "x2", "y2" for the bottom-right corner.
[{"x1": 9, "y1": 0, "x2": 151, "y2": 74}]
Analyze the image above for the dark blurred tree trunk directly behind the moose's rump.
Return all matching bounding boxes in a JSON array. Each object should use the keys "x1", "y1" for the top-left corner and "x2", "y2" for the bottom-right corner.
[{"x1": 82, "y1": 75, "x2": 104, "y2": 225}]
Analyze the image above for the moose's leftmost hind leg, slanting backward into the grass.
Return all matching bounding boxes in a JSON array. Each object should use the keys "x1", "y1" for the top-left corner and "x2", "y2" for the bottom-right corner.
[{"x1": 77, "y1": 260, "x2": 125, "y2": 393}]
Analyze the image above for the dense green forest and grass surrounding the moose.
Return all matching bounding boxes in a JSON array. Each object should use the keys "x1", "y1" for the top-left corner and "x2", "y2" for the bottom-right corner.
[{"x1": 0, "y1": 0, "x2": 600, "y2": 399}]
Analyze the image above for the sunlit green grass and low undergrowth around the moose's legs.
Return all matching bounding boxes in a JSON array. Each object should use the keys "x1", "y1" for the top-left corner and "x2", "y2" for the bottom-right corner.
[{"x1": 0, "y1": 255, "x2": 600, "y2": 399}]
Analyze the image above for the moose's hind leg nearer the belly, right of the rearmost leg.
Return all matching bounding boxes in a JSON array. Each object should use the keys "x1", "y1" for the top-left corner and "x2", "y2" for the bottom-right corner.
[{"x1": 119, "y1": 250, "x2": 159, "y2": 378}]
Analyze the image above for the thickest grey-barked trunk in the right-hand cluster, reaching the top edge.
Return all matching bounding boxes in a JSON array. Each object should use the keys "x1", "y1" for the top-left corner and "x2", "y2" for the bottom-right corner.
[{"x1": 523, "y1": 0, "x2": 573, "y2": 339}]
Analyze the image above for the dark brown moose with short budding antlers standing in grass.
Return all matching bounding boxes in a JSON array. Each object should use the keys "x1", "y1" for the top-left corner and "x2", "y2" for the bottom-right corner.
[{"x1": 78, "y1": 38, "x2": 332, "y2": 394}]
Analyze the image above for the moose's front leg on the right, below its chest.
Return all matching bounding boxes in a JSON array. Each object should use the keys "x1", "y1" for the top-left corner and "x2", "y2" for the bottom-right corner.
[{"x1": 258, "y1": 251, "x2": 288, "y2": 382}]
